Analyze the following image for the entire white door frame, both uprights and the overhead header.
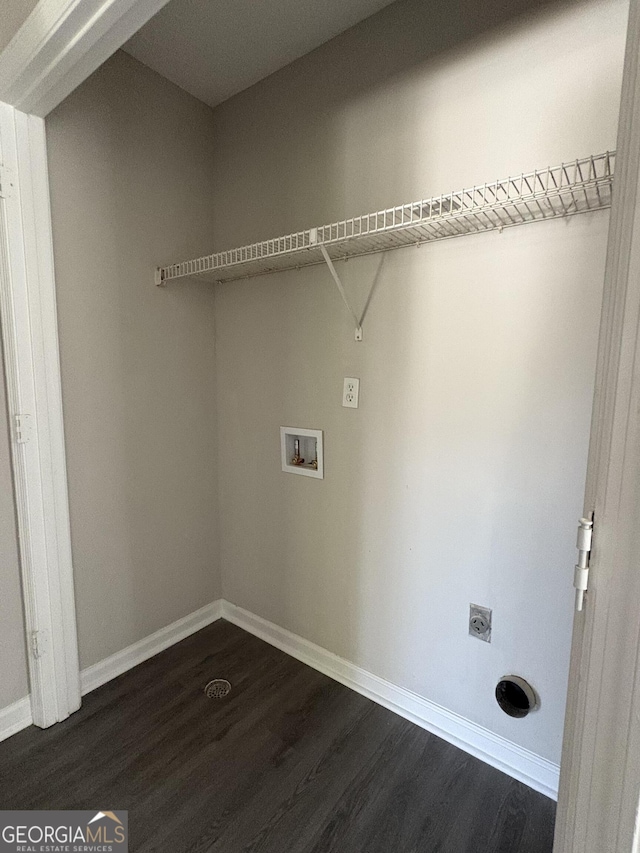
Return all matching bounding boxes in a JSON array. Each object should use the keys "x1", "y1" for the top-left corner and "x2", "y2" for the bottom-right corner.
[{"x1": 0, "y1": 0, "x2": 640, "y2": 853}]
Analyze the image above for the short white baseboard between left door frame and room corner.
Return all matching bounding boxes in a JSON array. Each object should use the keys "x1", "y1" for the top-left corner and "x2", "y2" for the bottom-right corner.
[{"x1": 80, "y1": 600, "x2": 222, "y2": 696}]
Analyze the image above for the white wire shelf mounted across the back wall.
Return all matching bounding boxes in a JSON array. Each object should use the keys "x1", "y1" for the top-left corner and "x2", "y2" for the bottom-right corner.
[{"x1": 156, "y1": 151, "x2": 615, "y2": 284}]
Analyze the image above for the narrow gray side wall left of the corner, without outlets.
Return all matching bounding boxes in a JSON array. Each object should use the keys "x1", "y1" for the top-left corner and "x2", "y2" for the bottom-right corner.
[{"x1": 47, "y1": 52, "x2": 220, "y2": 667}]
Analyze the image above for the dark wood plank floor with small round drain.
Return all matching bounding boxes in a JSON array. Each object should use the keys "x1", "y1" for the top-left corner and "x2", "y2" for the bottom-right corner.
[{"x1": 0, "y1": 622, "x2": 555, "y2": 853}]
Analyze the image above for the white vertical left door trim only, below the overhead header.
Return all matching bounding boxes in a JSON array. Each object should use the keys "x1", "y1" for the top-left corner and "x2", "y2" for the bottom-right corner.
[{"x1": 0, "y1": 103, "x2": 80, "y2": 727}]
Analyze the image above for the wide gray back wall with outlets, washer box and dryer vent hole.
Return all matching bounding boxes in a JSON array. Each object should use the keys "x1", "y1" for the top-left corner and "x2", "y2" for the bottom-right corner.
[{"x1": 213, "y1": 0, "x2": 627, "y2": 760}]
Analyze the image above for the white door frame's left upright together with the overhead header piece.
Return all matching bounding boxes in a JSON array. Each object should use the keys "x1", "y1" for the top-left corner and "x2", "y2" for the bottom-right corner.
[{"x1": 0, "y1": 0, "x2": 166, "y2": 728}]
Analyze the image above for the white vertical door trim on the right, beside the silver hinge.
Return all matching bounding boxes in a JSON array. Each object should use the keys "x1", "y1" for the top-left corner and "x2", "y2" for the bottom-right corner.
[{"x1": 554, "y1": 0, "x2": 640, "y2": 853}]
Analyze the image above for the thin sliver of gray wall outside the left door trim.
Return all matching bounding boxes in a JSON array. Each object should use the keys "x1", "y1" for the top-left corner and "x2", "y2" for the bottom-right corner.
[{"x1": 0, "y1": 344, "x2": 29, "y2": 709}]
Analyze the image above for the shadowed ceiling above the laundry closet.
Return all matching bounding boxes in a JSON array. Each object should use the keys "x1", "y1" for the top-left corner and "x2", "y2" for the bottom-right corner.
[{"x1": 123, "y1": 0, "x2": 398, "y2": 107}]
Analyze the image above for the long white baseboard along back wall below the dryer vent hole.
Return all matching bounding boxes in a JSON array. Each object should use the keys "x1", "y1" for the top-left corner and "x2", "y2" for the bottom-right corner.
[{"x1": 221, "y1": 600, "x2": 560, "y2": 799}]
